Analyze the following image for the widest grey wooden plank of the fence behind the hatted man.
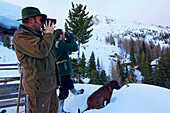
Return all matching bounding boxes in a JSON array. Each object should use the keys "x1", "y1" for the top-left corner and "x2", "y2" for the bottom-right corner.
[{"x1": 0, "y1": 84, "x2": 23, "y2": 94}]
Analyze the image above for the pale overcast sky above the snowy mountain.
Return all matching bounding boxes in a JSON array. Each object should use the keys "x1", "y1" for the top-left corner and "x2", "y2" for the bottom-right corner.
[{"x1": 2, "y1": 0, "x2": 170, "y2": 27}]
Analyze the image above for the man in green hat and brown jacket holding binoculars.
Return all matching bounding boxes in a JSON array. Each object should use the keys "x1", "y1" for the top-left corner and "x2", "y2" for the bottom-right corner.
[{"x1": 12, "y1": 7, "x2": 59, "y2": 113}]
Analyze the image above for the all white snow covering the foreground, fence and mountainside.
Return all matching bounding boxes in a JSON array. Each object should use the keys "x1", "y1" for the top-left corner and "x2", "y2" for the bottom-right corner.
[{"x1": 0, "y1": 1, "x2": 170, "y2": 113}]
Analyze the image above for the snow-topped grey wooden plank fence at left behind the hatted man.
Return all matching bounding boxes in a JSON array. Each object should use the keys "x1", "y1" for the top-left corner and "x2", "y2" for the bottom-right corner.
[{"x1": 0, "y1": 64, "x2": 28, "y2": 113}]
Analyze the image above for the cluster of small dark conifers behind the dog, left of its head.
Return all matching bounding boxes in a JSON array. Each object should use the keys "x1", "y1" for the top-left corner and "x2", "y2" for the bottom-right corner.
[{"x1": 71, "y1": 52, "x2": 110, "y2": 85}]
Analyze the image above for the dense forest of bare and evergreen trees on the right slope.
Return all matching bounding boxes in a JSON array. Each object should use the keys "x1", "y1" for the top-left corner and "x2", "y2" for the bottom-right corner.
[{"x1": 106, "y1": 35, "x2": 170, "y2": 88}]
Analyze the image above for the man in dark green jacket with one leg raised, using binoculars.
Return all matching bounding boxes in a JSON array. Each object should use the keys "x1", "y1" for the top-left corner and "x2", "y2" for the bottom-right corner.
[{"x1": 52, "y1": 29, "x2": 84, "y2": 113}]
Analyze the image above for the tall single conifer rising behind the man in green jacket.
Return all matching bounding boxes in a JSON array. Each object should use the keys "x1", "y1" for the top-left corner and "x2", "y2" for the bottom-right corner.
[{"x1": 65, "y1": 2, "x2": 93, "y2": 81}]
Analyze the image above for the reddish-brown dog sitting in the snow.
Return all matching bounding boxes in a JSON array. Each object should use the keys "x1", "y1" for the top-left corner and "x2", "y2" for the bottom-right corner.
[{"x1": 78, "y1": 80, "x2": 121, "y2": 113}]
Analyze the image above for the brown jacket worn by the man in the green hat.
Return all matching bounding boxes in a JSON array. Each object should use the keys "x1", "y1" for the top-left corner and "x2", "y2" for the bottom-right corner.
[{"x1": 12, "y1": 25, "x2": 57, "y2": 97}]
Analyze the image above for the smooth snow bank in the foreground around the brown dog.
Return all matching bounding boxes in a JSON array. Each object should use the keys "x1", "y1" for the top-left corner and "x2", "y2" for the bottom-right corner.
[{"x1": 0, "y1": 84, "x2": 170, "y2": 113}]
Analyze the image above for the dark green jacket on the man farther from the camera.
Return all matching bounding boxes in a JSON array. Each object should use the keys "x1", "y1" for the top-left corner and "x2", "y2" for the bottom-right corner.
[{"x1": 52, "y1": 39, "x2": 78, "y2": 77}]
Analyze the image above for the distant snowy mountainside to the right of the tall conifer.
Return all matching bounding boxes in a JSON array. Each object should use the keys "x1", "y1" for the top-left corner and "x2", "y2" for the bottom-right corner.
[{"x1": 71, "y1": 15, "x2": 170, "y2": 75}]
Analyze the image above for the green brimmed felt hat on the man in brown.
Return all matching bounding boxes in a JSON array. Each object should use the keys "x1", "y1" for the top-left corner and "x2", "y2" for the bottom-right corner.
[{"x1": 17, "y1": 7, "x2": 47, "y2": 21}]
